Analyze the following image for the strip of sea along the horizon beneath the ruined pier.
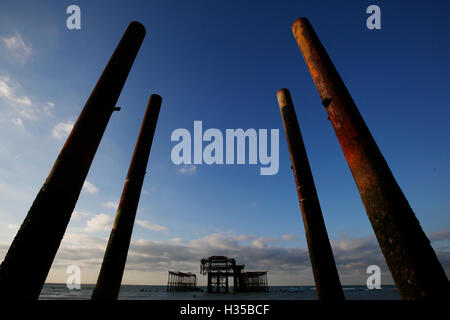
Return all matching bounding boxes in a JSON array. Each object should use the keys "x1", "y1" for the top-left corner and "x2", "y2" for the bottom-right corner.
[{"x1": 39, "y1": 283, "x2": 400, "y2": 300}]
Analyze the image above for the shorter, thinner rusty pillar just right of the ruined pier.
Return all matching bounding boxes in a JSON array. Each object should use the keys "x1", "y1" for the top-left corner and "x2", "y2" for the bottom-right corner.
[{"x1": 277, "y1": 89, "x2": 345, "y2": 300}]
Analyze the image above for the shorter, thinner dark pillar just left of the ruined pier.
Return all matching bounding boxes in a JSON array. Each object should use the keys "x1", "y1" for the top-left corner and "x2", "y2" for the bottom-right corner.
[{"x1": 92, "y1": 94, "x2": 162, "y2": 300}]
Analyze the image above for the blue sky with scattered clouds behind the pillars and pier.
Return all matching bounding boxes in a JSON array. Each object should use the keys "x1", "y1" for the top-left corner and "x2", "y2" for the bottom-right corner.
[{"x1": 0, "y1": 1, "x2": 450, "y2": 285}]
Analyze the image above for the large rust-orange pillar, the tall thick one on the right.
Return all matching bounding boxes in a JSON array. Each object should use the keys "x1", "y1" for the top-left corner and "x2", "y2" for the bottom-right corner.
[{"x1": 292, "y1": 18, "x2": 450, "y2": 299}]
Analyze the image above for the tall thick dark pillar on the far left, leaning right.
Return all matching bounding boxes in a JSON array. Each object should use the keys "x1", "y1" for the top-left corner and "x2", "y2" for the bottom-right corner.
[{"x1": 0, "y1": 22, "x2": 145, "y2": 299}]
